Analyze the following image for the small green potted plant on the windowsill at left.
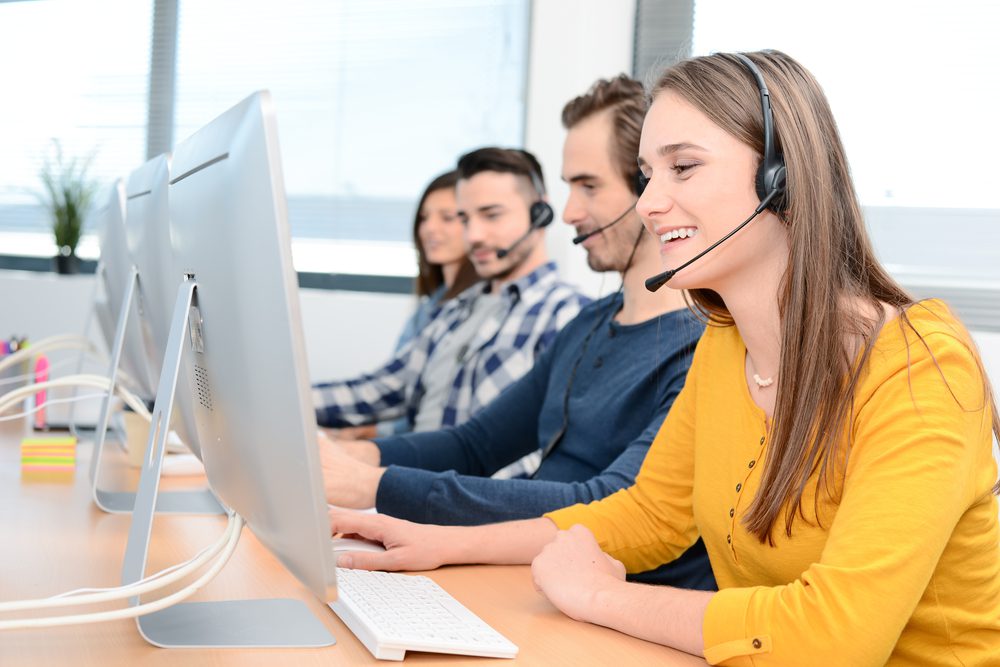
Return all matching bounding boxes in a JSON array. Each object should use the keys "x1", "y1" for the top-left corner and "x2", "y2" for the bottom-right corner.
[{"x1": 38, "y1": 140, "x2": 98, "y2": 273}]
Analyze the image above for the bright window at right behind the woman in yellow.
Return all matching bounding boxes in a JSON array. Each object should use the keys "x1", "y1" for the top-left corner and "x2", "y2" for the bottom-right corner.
[{"x1": 693, "y1": 0, "x2": 1000, "y2": 331}]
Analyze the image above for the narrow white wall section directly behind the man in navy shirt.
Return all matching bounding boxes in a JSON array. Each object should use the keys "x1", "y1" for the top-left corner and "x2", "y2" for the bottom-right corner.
[{"x1": 525, "y1": 0, "x2": 635, "y2": 295}]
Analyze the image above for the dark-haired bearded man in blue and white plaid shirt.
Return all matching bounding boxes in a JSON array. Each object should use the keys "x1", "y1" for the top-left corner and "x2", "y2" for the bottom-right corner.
[{"x1": 313, "y1": 148, "x2": 588, "y2": 460}]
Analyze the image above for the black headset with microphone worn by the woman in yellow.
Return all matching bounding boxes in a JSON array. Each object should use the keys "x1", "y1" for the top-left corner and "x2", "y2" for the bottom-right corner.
[{"x1": 640, "y1": 53, "x2": 787, "y2": 292}]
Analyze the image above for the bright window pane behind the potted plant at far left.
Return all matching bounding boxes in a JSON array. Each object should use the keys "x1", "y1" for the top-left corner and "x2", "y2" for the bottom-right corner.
[{"x1": 0, "y1": 0, "x2": 152, "y2": 256}]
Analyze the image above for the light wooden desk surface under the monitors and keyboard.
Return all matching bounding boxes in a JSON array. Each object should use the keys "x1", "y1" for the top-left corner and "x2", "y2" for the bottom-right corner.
[{"x1": 0, "y1": 422, "x2": 705, "y2": 667}]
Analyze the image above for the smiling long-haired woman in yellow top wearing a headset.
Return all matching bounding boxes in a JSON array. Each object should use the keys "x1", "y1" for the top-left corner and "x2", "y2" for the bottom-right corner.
[{"x1": 332, "y1": 52, "x2": 1000, "y2": 667}]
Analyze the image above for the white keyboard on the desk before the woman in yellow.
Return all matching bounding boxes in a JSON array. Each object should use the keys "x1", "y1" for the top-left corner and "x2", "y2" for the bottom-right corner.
[{"x1": 330, "y1": 568, "x2": 517, "y2": 660}]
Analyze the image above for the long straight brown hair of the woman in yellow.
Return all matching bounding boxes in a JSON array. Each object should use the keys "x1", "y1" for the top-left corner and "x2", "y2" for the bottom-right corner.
[{"x1": 652, "y1": 51, "x2": 1000, "y2": 542}]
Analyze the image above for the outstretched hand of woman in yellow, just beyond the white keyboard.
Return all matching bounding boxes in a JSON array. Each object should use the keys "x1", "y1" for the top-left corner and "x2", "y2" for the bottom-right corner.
[{"x1": 330, "y1": 509, "x2": 448, "y2": 571}]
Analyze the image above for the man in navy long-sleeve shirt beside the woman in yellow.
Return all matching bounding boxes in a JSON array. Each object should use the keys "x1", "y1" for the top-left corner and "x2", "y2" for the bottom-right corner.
[{"x1": 321, "y1": 76, "x2": 715, "y2": 589}]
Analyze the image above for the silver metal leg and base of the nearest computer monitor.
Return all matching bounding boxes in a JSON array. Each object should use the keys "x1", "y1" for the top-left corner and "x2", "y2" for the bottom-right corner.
[{"x1": 121, "y1": 280, "x2": 335, "y2": 648}]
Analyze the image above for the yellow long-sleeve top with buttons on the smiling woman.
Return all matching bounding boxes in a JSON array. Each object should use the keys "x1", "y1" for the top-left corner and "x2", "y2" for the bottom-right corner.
[{"x1": 546, "y1": 301, "x2": 1000, "y2": 667}]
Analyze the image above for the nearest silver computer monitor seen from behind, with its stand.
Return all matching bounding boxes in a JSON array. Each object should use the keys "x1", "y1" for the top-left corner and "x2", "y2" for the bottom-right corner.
[{"x1": 122, "y1": 91, "x2": 336, "y2": 646}]
